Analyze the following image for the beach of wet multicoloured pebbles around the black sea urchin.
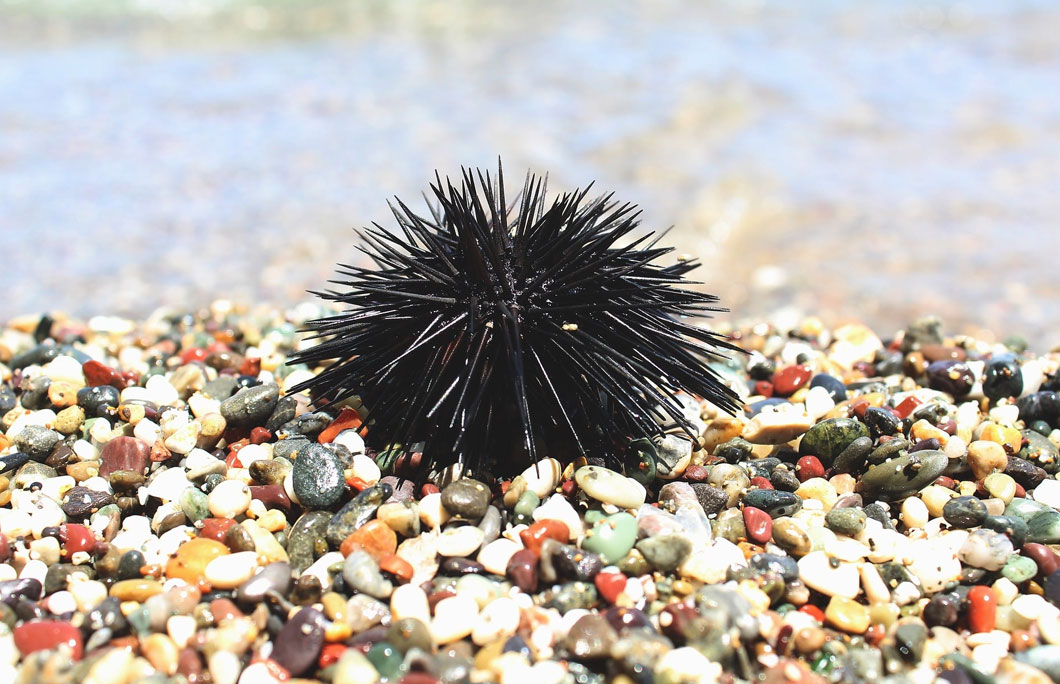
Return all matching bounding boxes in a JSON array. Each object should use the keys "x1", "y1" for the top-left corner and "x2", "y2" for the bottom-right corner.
[{"x1": 0, "y1": 301, "x2": 1060, "y2": 684}]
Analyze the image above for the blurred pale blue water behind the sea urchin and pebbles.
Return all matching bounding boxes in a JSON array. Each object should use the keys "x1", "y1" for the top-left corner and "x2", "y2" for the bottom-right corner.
[{"x1": 0, "y1": 0, "x2": 1060, "y2": 341}]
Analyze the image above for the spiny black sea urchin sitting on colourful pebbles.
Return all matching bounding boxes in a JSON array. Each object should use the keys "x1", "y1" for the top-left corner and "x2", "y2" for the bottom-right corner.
[{"x1": 286, "y1": 165, "x2": 738, "y2": 470}]
